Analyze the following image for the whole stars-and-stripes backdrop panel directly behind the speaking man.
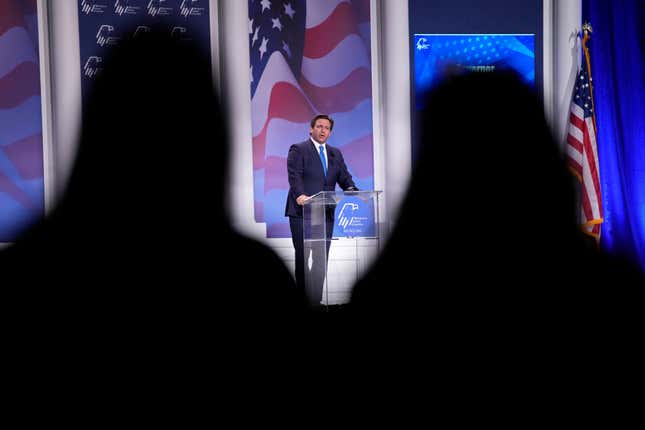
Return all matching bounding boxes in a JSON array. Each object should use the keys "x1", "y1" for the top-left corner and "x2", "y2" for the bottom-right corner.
[{"x1": 248, "y1": 0, "x2": 374, "y2": 238}]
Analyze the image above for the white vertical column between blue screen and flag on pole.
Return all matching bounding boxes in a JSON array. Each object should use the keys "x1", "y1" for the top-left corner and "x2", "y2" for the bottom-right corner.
[{"x1": 553, "y1": 0, "x2": 582, "y2": 149}]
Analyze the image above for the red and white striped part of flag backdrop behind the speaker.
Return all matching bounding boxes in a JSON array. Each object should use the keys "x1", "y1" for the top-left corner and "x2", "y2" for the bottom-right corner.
[{"x1": 251, "y1": 0, "x2": 373, "y2": 225}]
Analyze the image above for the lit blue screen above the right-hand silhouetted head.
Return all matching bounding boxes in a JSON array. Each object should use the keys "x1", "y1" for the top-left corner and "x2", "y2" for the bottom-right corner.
[{"x1": 412, "y1": 34, "x2": 535, "y2": 108}]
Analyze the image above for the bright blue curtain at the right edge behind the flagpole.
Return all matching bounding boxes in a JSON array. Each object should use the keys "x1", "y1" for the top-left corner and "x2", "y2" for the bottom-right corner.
[{"x1": 582, "y1": 0, "x2": 645, "y2": 270}]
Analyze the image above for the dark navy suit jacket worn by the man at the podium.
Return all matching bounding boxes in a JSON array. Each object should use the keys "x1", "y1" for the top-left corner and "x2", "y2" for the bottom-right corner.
[{"x1": 284, "y1": 139, "x2": 358, "y2": 217}]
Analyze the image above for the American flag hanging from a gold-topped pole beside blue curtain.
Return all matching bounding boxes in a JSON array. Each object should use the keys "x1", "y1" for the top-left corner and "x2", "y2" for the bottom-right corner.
[{"x1": 566, "y1": 24, "x2": 603, "y2": 239}]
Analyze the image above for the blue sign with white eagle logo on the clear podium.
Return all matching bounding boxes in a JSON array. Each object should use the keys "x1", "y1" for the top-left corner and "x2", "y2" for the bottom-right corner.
[{"x1": 334, "y1": 196, "x2": 376, "y2": 237}]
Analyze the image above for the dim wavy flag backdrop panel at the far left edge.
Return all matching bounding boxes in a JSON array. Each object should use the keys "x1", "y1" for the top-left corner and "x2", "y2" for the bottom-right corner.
[{"x1": 0, "y1": 0, "x2": 45, "y2": 242}]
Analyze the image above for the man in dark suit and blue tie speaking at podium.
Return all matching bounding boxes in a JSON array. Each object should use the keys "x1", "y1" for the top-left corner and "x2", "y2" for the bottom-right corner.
[{"x1": 285, "y1": 115, "x2": 358, "y2": 306}]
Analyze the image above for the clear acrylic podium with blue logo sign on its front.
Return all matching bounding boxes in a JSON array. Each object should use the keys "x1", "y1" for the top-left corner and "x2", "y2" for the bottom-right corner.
[{"x1": 302, "y1": 191, "x2": 382, "y2": 309}]
